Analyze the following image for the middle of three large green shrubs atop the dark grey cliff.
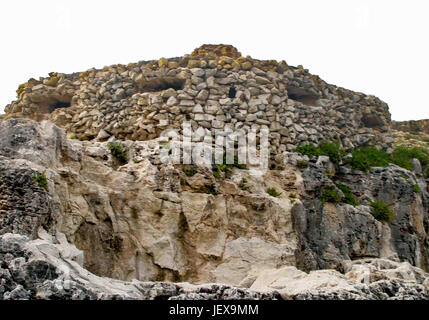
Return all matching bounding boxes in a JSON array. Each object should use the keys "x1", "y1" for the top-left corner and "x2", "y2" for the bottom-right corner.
[{"x1": 349, "y1": 147, "x2": 390, "y2": 172}]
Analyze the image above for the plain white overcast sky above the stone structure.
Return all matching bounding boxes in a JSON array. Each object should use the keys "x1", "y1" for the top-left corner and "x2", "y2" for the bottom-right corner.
[{"x1": 0, "y1": 0, "x2": 429, "y2": 120}]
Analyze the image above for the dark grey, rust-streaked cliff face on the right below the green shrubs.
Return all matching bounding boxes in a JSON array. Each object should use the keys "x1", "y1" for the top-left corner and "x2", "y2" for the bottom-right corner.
[{"x1": 292, "y1": 157, "x2": 429, "y2": 270}]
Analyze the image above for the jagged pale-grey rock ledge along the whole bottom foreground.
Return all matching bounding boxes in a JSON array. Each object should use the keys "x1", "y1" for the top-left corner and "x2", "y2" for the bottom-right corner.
[{"x1": 0, "y1": 231, "x2": 429, "y2": 300}]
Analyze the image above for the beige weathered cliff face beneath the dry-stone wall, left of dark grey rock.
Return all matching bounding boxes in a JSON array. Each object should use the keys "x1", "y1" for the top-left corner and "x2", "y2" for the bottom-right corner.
[{"x1": 0, "y1": 119, "x2": 296, "y2": 284}]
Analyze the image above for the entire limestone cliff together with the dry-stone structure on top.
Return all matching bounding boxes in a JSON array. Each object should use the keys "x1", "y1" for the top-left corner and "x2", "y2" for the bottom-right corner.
[{"x1": 0, "y1": 45, "x2": 429, "y2": 299}]
